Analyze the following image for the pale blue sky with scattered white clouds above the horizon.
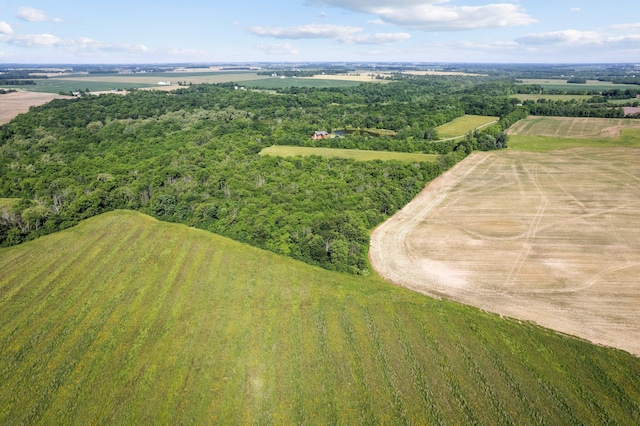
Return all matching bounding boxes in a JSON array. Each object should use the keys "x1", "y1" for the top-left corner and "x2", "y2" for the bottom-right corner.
[{"x1": 0, "y1": 0, "x2": 640, "y2": 63}]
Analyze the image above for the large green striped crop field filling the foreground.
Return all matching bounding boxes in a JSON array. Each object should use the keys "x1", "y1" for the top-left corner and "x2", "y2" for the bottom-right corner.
[{"x1": 0, "y1": 211, "x2": 640, "y2": 424}]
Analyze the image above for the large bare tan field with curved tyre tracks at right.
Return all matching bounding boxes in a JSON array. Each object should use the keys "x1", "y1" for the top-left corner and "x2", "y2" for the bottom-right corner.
[{"x1": 370, "y1": 148, "x2": 640, "y2": 355}]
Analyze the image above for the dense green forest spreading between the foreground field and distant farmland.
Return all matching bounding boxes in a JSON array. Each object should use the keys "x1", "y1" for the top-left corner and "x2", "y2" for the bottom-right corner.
[{"x1": 0, "y1": 77, "x2": 632, "y2": 273}]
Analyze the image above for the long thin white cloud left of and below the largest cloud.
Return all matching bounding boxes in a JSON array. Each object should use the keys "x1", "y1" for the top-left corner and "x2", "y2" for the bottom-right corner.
[{"x1": 249, "y1": 24, "x2": 411, "y2": 44}]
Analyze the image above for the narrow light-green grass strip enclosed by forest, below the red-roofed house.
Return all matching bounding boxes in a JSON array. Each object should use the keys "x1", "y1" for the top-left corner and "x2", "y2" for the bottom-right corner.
[{"x1": 260, "y1": 145, "x2": 438, "y2": 163}]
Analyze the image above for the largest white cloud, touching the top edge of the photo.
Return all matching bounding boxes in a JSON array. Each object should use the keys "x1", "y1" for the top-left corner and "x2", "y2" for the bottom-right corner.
[{"x1": 307, "y1": 0, "x2": 537, "y2": 31}]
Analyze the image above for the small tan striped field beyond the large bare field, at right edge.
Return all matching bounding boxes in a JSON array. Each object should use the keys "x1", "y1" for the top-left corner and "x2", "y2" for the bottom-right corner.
[{"x1": 507, "y1": 116, "x2": 640, "y2": 138}]
